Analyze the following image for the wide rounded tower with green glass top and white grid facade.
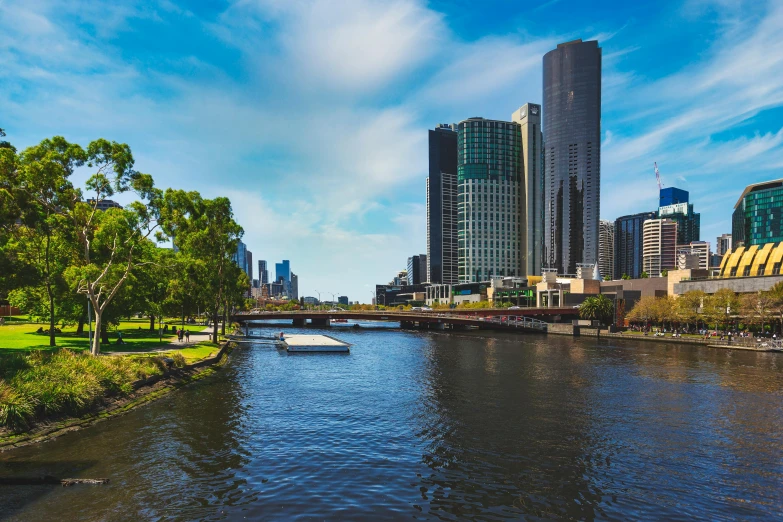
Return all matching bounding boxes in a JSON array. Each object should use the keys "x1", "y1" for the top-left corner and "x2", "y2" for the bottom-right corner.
[{"x1": 457, "y1": 118, "x2": 525, "y2": 283}]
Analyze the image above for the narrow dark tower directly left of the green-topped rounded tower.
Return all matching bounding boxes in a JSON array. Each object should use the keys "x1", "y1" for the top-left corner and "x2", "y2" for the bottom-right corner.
[{"x1": 426, "y1": 124, "x2": 458, "y2": 285}]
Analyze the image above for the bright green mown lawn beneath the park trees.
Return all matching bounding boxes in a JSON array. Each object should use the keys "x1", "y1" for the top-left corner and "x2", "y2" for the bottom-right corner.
[{"x1": 0, "y1": 319, "x2": 178, "y2": 353}]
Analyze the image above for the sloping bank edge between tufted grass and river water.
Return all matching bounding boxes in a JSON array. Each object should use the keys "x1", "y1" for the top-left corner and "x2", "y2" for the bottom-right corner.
[{"x1": 0, "y1": 341, "x2": 233, "y2": 452}]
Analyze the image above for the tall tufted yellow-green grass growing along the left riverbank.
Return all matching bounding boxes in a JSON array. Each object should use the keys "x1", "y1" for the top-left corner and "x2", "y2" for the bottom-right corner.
[{"x1": 0, "y1": 349, "x2": 164, "y2": 431}]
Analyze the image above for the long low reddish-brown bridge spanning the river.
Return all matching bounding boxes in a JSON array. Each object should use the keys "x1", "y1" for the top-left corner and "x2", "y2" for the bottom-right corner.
[{"x1": 231, "y1": 308, "x2": 579, "y2": 332}]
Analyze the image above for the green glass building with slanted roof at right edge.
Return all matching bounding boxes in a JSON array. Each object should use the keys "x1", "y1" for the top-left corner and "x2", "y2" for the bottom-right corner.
[{"x1": 731, "y1": 179, "x2": 783, "y2": 248}]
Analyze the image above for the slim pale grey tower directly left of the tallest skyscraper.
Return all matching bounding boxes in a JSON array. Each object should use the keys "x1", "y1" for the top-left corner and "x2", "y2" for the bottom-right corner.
[{"x1": 511, "y1": 103, "x2": 544, "y2": 275}]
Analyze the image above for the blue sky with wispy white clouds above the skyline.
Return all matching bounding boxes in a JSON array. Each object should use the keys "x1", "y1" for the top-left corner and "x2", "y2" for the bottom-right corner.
[{"x1": 0, "y1": 0, "x2": 783, "y2": 302}]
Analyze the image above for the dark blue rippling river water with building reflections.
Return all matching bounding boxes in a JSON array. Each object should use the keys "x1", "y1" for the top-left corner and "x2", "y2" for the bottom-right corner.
[{"x1": 0, "y1": 326, "x2": 783, "y2": 521}]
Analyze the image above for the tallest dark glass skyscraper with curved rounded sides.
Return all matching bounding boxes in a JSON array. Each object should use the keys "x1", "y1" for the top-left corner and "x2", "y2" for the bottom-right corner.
[{"x1": 543, "y1": 40, "x2": 601, "y2": 274}]
